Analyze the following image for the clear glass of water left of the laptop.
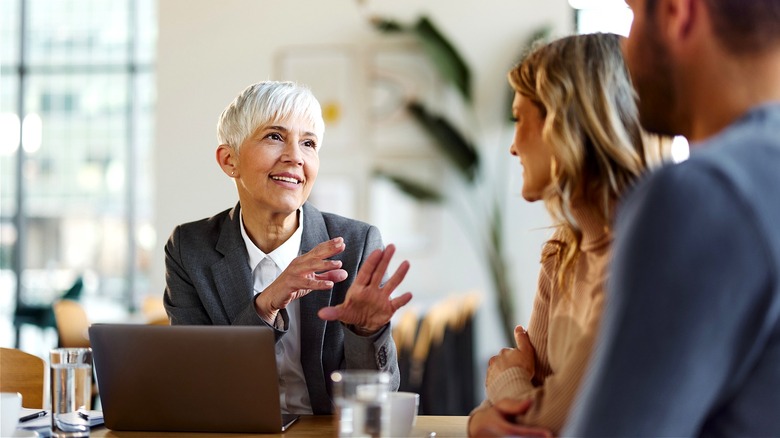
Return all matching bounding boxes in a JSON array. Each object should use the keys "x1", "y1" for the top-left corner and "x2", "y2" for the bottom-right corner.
[{"x1": 49, "y1": 348, "x2": 92, "y2": 438}]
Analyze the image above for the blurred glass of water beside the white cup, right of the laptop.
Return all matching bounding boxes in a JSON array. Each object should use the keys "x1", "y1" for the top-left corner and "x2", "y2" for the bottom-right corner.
[{"x1": 330, "y1": 370, "x2": 390, "y2": 438}]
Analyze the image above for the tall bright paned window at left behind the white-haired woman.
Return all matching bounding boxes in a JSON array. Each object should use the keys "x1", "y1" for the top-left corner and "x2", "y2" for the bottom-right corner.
[{"x1": 0, "y1": 0, "x2": 157, "y2": 350}]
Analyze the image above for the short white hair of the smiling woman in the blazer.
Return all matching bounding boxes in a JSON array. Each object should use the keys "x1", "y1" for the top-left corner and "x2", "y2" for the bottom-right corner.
[{"x1": 217, "y1": 81, "x2": 325, "y2": 151}]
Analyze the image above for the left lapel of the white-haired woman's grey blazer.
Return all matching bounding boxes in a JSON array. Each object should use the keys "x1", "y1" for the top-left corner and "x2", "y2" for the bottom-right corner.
[{"x1": 211, "y1": 204, "x2": 252, "y2": 322}]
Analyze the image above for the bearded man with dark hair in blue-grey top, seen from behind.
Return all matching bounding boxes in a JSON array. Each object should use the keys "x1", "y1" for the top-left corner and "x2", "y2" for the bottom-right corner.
[{"x1": 563, "y1": 0, "x2": 780, "y2": 437}]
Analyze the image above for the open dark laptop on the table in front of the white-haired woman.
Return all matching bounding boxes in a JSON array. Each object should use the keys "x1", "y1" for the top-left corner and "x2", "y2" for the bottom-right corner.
[{"x1": 89, "y1": 324, "x2": 298, "y2": 433}]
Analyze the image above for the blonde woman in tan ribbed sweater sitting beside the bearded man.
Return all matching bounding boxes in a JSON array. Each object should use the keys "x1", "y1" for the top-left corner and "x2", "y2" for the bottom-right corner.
[{"x1": 469, "y1": 34, "x2": 660, "y2": 436}]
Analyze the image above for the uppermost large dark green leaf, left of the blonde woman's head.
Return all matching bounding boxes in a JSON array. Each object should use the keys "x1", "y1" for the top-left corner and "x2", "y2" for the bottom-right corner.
[{"x1": 412, "y1": 17, "x2": 471, "y2": 103}]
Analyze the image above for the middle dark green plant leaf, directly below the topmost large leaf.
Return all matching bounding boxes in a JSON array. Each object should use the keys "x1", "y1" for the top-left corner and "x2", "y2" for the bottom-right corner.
[{"x1": 407, "y1": 101, "x2": 479, "y2": 182}]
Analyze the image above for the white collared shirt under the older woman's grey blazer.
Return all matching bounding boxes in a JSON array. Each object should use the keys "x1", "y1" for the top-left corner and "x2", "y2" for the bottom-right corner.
[{"x1": 241, "y1": 209, "x2": 312, "y2": 414}]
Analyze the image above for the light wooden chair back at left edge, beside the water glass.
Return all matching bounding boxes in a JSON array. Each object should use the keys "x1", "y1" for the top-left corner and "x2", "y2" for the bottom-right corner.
[{"x1": 0, "y1": 348, "x2": 46, "y2": 409}]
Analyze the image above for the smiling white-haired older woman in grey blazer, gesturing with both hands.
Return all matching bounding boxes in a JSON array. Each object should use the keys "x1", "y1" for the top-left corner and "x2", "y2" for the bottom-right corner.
[{"x1": 164, "y1": 81, "x2": 412, "y2": 414}]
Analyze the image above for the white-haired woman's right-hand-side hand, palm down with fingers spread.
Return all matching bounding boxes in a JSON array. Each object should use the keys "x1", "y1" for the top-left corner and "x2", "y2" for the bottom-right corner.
[{"x1": 318, "y1": 245, "x2": 412, "y2": 336}]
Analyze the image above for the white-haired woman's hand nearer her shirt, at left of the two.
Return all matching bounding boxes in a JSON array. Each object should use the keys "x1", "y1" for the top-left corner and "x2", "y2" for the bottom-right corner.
[{"x1": 255, "y1": 237, "x2": 346, "y2": 324}]
